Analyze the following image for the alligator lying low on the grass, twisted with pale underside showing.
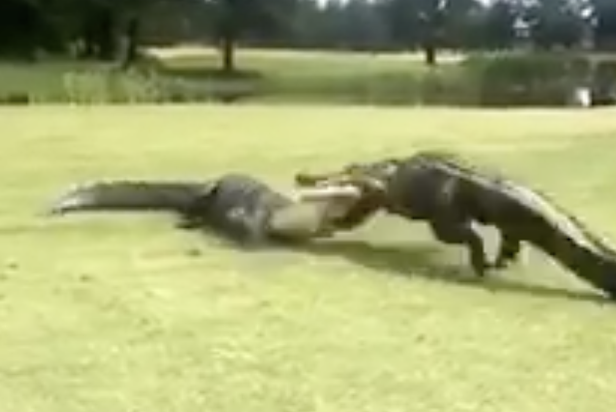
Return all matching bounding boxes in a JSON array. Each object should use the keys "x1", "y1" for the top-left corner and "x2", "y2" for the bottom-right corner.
[{"x1": 49, "y1": 174, "x2": 380, "y2": 245}]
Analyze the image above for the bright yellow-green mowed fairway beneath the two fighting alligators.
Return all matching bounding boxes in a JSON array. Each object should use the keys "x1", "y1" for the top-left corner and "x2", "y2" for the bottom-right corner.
[{"x1": 0, "y1": 106, "x2": 616, "y2": 412}]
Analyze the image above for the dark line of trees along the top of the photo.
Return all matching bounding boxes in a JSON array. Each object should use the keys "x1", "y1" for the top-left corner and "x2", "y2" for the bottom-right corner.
[{"x1": 0, "y1": 0, "x2": 616, "y2": 71}]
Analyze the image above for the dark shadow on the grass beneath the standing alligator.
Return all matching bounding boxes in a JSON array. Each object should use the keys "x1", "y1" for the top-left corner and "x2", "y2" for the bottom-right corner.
[{"x1": 298, "y1": 240, "x2": 611, "y2": 303}]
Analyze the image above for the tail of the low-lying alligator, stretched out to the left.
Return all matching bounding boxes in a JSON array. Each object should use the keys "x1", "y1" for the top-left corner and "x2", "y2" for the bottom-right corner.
[{"x1": 49, "y1": 181, "x2": 215, "y2": 215}]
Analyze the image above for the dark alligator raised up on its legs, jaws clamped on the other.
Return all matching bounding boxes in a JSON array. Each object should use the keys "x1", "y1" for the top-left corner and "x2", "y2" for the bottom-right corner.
[{"x1": 296, "y1": 151, "x2": 616, "y2": 299}]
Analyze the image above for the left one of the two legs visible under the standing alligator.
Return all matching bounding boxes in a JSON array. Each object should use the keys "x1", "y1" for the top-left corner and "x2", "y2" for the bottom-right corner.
[{"x1": 430, "y1": 219, "x2": 490, "y2": 277}]
